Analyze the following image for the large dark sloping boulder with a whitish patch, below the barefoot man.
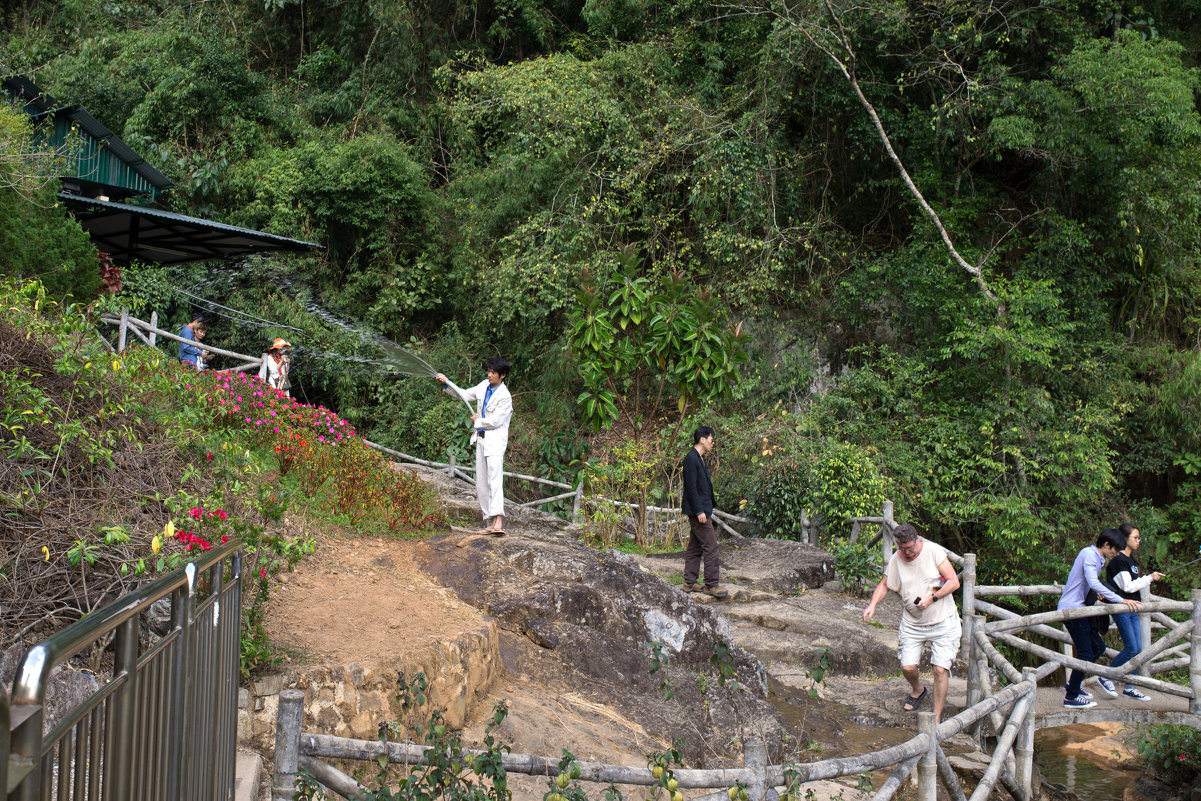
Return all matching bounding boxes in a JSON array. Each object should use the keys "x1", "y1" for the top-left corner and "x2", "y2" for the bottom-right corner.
[{"x1": 418, "y1": 521, "x2": 779, "y2": 764}]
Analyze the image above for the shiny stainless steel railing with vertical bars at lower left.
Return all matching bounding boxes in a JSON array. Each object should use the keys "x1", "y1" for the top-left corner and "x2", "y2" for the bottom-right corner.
[{"x1": 0, "y1": 542, "x2": 241, "y2": 801}]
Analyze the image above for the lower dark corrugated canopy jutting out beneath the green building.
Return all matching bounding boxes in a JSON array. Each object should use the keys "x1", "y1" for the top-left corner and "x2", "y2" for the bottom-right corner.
[{"x1": 59, "y1": 192, "x2": 321, "y2": 264}]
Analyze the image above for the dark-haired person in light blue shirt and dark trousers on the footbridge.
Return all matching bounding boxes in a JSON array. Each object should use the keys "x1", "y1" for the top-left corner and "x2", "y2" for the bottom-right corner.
[{"x1": 1056, "y1": 528, "x2": 1140, "y2": 709}]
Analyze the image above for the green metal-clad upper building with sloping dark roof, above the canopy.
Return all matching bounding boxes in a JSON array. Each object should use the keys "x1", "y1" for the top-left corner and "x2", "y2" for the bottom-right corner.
[{"x1": 4, "y1": 76, "x2": 173, "y2": 199}]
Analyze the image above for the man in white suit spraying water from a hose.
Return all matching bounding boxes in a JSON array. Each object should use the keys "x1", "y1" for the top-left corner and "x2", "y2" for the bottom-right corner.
[{"x1": 435, "y1": 357, "x2": 513, "y2": 537}]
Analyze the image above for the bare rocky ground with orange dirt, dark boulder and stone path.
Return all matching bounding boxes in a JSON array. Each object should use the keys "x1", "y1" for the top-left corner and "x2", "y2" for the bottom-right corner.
[{"x1": 260, "y1": 467, "x2": 1152, "y2": 801}]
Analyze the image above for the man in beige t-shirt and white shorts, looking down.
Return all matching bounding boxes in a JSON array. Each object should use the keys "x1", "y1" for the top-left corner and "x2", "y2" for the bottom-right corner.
[{"x1": 862, "y1": 524, "x2": 963, "y2": 722}]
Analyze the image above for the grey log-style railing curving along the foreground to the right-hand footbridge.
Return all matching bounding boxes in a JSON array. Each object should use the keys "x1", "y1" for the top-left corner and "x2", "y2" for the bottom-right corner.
[{"x1": 274, "y1": 583, "x2": 1201, "y2": 801}]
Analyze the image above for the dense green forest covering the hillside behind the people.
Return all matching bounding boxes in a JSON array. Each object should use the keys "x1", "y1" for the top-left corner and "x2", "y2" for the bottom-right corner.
[{"x1": 7, "y1": 0, "x2": 1201, "y2": 581}]
